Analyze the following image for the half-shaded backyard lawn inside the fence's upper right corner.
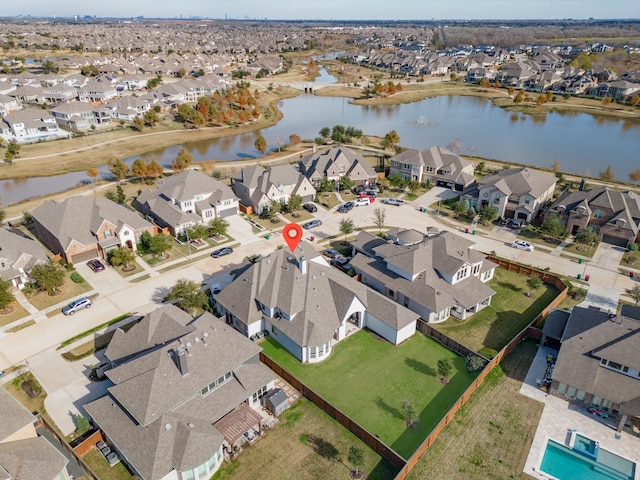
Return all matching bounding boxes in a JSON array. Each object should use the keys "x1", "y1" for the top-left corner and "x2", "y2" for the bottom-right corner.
[{"x1": 433, "y1": 268, "x2": 558, "y2": 352}]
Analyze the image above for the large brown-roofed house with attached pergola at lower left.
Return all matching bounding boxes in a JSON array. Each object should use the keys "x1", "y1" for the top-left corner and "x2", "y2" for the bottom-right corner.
[{"x1": 84, "y1": 305, "x2": 276, "y2": 480}]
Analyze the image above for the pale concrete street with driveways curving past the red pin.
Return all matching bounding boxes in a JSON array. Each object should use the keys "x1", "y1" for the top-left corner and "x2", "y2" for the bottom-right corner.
[{"x1": 0, "y1": 188, "x2": 634, "y2": 434}]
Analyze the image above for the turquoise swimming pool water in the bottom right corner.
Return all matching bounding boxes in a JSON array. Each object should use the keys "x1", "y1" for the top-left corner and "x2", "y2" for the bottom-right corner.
[{"x1": 540, "y1": 440, "x2": 636, "y2": 480}]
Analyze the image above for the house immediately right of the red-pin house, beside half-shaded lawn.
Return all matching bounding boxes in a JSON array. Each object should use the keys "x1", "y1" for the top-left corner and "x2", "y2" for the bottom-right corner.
[{"x1": 349, "y1": 228, "x2": 497, "y2": 323}]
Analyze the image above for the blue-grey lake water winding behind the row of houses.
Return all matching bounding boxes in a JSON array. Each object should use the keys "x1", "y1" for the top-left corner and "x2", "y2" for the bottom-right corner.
[{"x1": 0, "y1": 92, "x2": 640, "y2": 206}]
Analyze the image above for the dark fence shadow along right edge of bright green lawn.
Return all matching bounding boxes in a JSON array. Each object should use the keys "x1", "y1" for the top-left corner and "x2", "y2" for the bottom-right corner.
[{"x1": 390, "y1": 367, "x2": 475, "y2": 459}]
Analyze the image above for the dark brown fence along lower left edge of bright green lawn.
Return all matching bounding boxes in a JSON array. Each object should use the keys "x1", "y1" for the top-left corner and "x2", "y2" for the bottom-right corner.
[{"x1": 260, "y1": 352, "x2": 407, "y2": 469}]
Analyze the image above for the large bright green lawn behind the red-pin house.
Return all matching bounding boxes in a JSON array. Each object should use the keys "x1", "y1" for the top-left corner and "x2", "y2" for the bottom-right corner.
[{"x1": 261, "y1": 330, "x2": 475, "y2": 458}]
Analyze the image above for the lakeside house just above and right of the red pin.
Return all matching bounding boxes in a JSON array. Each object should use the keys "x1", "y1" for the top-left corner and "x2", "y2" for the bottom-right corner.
[{"x1": 298, "y1": 146, "x2": 378, "y2": 188}]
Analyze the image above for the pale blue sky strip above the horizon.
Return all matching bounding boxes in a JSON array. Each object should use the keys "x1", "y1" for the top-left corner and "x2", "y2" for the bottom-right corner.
[{"x1": 0, "y1": 0, "x2": 640, "y2": 20}]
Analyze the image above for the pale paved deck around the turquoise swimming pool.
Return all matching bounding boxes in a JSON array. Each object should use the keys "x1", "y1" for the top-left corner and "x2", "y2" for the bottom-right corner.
[{"x1": 520, "y1": 347, "x2": 640, "y2": 480}]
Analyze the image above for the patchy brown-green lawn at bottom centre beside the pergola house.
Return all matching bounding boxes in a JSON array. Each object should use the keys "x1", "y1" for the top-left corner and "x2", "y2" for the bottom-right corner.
[{"x1": 213, "y1": 399, "x2": 397, "y2": 480}]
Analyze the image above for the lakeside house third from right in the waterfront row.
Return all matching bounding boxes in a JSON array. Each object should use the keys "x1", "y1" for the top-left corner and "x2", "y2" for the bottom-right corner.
[{"x1": 389, "y1": 146, "x2": 475, "y2": 191}]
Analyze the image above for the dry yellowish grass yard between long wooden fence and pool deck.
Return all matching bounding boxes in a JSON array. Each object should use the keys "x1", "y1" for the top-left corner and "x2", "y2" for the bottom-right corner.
[{"x1": 408, "y1": 340, "x2": 543, "y2": 480}]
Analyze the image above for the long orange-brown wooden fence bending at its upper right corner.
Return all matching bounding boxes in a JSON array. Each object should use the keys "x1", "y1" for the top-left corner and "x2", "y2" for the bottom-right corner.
[{"x1": 395, "y1": 256, "x2": 569, "y2": 480}]
